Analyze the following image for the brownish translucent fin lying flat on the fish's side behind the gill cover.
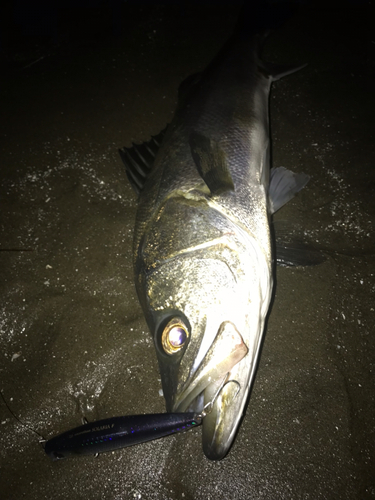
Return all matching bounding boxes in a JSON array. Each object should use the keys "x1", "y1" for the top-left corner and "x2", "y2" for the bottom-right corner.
[{"x1": 189, "y1": 132, "x2": 234, "y2": 195}]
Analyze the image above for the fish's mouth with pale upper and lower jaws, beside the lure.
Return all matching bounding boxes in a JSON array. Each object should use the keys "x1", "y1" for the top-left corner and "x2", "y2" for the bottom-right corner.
[{"x1": 172, "y1": 321, "x2": 248, "y2": 460}]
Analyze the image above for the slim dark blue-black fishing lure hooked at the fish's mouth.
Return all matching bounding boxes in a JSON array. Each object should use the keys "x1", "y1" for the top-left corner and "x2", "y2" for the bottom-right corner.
[{"x1": 44, "y1": 413, "x2": 204, "y2": 460}]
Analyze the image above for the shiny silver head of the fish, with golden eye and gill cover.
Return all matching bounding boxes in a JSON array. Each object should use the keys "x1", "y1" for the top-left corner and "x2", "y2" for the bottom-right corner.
[{"x1": 137, "y1": 196, "x2": 271, "y2": 460}]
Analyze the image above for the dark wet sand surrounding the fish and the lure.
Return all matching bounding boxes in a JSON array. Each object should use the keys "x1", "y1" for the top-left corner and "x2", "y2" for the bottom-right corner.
[{"x1": 0, "y1": 6, "x2": 375, "y2": 500}]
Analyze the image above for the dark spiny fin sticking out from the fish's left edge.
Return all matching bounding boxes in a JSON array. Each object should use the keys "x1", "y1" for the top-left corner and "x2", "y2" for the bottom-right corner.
[{"x1": 119, "y1": 127, "x2": 167, "y2": 194}]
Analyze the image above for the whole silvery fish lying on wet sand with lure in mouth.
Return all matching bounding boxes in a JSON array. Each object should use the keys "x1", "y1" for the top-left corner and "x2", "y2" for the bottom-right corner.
[{"x1": 120, "y1": 2, "x2": 309, "y2": 460}]
